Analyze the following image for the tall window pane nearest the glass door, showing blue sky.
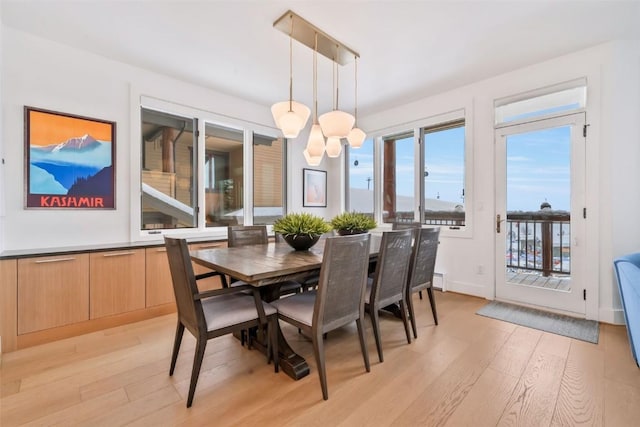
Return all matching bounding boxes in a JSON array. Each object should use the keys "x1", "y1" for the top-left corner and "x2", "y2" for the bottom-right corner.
[{"x1": 423, "y1": 122, "x2": 465, "y2": 226}]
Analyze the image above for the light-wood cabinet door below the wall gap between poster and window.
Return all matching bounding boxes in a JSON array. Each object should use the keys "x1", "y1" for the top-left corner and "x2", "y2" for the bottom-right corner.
[{"x1": 90, "y1": 249, "x2": 145, "y2": 319}]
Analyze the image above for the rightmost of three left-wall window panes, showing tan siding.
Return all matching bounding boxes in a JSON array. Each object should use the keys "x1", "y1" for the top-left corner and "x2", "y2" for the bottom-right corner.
[{"x1": 253, "y1": 134, "x2": 285, "y2": 225}]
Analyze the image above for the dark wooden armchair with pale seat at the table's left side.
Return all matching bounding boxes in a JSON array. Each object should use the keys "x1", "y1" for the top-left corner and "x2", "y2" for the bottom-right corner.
[{"x1": 164, "y1": 236, "x2": 279, "y2": 408}]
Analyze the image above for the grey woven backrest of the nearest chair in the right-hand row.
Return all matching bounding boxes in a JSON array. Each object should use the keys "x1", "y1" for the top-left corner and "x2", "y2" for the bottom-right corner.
[{"x1": 312, "y1": 233, "x2": 371, "y2": 333}]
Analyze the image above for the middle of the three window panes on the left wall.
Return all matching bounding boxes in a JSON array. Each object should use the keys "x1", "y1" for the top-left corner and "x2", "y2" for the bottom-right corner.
[{"x1": 204, "y1": 123, "x2": 244, "y2": 227}]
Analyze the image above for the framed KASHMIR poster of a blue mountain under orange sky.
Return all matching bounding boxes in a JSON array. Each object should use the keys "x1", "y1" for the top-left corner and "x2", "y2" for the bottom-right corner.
[{"x1": 24, "y1": 106, "x2": 116, "y2": 209}]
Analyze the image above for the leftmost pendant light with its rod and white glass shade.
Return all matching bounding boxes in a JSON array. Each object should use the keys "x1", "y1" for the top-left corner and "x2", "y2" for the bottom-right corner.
[{"x1": 271, "y1": 13, "x2": 311, "y2": 138}]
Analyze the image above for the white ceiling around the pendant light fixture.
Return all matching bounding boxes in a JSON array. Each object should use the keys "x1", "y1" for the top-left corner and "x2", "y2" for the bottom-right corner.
[{"x1": 1, "y1": 0, "x2": 640, "y2": 116}]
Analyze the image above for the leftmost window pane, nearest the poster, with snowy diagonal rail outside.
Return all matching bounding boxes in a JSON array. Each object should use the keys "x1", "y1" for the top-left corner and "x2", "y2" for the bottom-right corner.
[{"x1": 141, "y1": 108, "x2": 197, "y2": 230}]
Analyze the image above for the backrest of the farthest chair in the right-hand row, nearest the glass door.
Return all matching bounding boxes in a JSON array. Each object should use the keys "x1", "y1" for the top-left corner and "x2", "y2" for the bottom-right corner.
[{"x1": 409, "y1": 227, "x2": 440, "y2": 289}]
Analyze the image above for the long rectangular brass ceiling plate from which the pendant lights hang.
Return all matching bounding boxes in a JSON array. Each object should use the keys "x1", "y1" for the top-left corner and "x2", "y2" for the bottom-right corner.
[{"x1": 273, "y1": 10, "x2": 360, "y2": 65}]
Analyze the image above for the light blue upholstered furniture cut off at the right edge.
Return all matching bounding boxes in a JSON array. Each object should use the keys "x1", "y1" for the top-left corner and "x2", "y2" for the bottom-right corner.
[{"x1": 613, "y1": 252, "x2": 640, "y2": 367}]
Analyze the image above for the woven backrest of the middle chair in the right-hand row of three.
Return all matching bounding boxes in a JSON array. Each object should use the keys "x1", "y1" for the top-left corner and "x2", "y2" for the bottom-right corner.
[{"x1": 369, "y1": 228, "x2": 417, "y2": 306}]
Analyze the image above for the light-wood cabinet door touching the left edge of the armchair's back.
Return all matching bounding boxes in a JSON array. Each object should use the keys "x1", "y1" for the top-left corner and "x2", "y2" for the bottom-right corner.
[{"x1": 145, "y1": 247, "x2": 175, "y2": 307}]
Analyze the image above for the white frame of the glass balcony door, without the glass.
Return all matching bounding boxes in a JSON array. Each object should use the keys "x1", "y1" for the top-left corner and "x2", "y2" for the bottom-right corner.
[{"x1": 493, "y1": 111, "x2": 597, "y2": 317}]
